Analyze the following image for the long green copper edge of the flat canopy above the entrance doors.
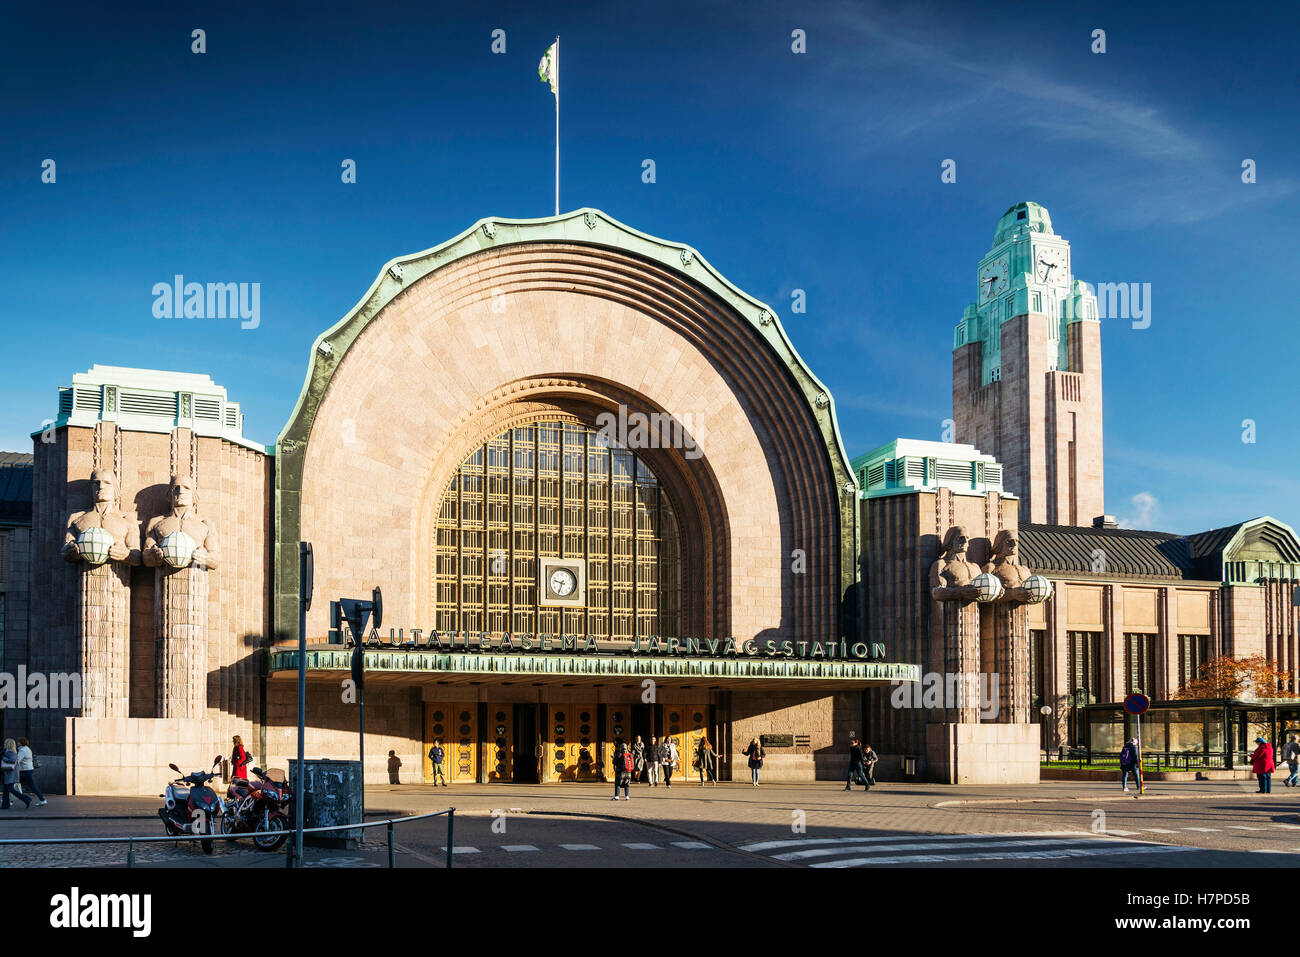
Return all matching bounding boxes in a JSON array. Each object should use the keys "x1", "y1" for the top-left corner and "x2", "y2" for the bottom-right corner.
[{"x1": 269, "y1": 649, "x2": 920, "y2": 681}]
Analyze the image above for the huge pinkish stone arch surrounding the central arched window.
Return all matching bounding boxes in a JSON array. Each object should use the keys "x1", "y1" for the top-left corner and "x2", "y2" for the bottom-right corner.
[{"x1": 277, "y1": 224, "x2": 852, "y2": 641}]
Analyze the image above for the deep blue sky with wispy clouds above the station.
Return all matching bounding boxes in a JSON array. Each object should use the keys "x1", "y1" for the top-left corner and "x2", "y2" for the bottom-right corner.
[{"x1": 0, "y1": 3, "x2": 1300, "y2": 532}]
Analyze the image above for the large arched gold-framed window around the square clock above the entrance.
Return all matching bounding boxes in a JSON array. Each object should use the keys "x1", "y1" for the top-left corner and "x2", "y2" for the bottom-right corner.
[{"x1": 430, "y1": 419, "x2": 681, "y2": 640}]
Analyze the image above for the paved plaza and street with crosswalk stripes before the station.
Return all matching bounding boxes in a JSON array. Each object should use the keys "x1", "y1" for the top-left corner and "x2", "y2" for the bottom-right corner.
[{"x1": 0, "y1": 780, "x2": 1300, "y2": 869}]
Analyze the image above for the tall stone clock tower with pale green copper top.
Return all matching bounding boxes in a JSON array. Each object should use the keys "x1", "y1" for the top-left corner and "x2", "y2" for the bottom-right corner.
[{"x1": 953, "y1": 203, "x2": 1105, "y2": 525}]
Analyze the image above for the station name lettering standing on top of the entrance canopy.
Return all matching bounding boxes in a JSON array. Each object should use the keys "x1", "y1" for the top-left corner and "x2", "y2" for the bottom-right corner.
[{"x1": 330, "y1": 624, "x2": 885, "y2": 662}]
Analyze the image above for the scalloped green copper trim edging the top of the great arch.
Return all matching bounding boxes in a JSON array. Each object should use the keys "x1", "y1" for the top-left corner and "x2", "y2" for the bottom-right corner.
[{"x1": 273, "y1": 208, "x2": 858, "y2": 637}]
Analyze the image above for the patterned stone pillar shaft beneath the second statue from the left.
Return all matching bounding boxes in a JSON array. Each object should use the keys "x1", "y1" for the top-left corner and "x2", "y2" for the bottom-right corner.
[{"x1": 153, "y1": 564, "x2": 208, "y2": 718}]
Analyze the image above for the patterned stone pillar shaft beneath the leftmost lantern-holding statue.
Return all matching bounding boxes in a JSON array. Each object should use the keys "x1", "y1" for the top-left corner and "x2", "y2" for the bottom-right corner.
[{"x1": 78, "y1": 562, "x2": 131, "y2": 718}]
